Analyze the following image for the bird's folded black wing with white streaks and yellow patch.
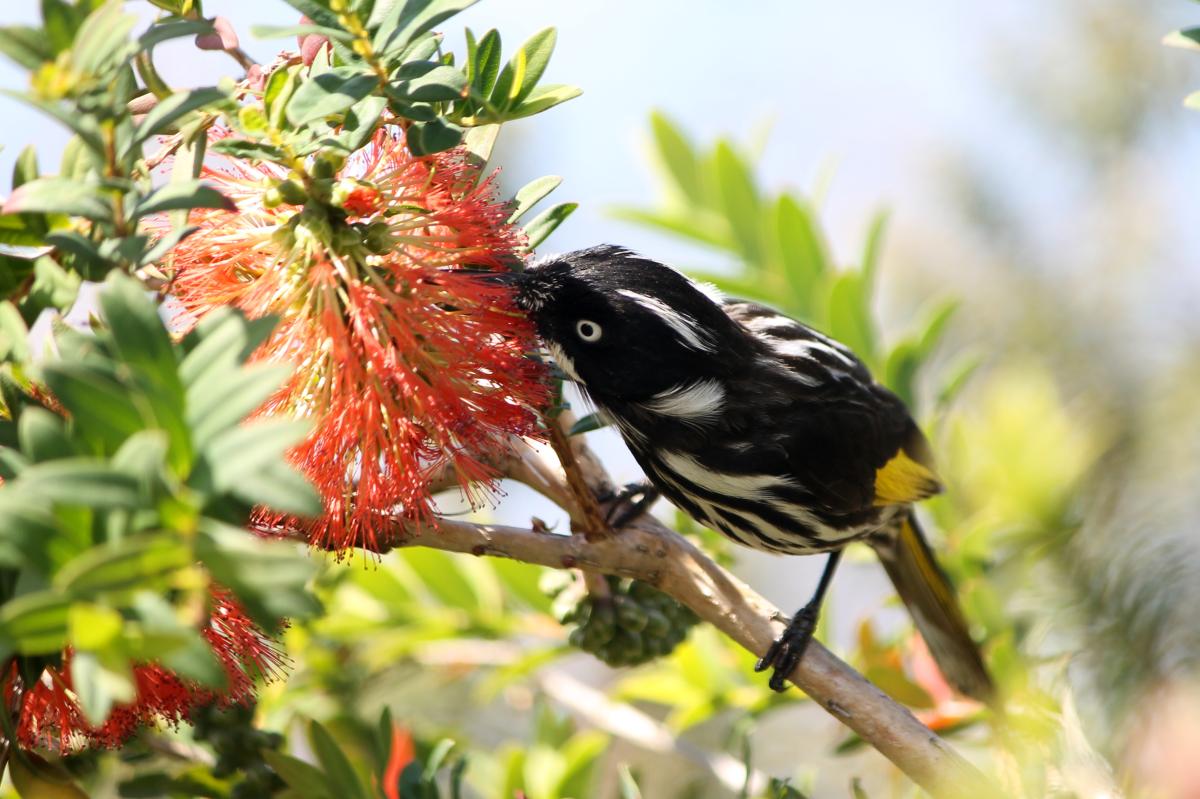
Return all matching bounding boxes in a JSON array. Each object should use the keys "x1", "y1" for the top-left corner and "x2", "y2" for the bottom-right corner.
[{"x1": 725, "y1": 300, "x2": 941, "y2": 513}]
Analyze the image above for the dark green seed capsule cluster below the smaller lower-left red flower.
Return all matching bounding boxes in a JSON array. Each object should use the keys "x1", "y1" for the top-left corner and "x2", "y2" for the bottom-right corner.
[{"x1": 192, "y1": 704, "x2": 284, "y2": 799}]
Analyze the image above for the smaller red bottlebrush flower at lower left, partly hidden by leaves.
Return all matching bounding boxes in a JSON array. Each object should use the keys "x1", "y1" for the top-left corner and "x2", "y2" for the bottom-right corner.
[{"x1": 6, "y1": 588, "x2": 286, "y2": 752}]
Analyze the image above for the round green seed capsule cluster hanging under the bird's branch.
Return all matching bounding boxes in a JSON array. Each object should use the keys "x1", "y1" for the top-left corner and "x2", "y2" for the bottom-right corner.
[{"x1": 542, "y1": 571, "x2": 698, "y2": 666}]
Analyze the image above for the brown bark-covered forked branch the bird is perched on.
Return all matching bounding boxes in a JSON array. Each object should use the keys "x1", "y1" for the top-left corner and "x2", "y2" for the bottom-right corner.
[{"x1": 278, "y1": 420, "x2": 1002, "y2": 799}]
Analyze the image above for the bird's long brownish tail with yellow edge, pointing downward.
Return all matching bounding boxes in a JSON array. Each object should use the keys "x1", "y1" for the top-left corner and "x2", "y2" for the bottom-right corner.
[{"x1": 870, "y1": 510, "x2": 996, "y2": 702}]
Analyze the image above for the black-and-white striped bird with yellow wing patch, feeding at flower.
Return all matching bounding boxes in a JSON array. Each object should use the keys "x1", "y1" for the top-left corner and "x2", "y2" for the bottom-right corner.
[{"x1": 501, "y1": 245, "x2": 995, "y2": 701}]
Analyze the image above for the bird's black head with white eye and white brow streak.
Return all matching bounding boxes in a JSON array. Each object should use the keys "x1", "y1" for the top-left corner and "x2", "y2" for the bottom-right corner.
[{"x1": 517, "y1": 245, "x2": 748, "y2": 401}]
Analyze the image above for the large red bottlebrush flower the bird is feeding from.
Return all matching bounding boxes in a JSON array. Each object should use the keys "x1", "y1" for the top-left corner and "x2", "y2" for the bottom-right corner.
[{"x1": 174, "y1": 132, "x2": 547, "y2": 551}]
